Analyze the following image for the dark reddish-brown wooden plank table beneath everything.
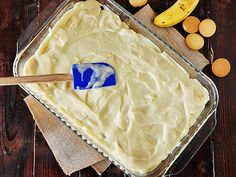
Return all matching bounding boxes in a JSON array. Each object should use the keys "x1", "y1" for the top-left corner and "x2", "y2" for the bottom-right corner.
[{"x1": 0, "y1": 0, "x2": 236, "y2": 177}]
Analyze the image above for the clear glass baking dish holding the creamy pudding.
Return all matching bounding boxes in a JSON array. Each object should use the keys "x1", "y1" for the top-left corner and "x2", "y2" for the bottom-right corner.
[{"x1": 13, "y1": 0, "x2": 219, "y2": 177}]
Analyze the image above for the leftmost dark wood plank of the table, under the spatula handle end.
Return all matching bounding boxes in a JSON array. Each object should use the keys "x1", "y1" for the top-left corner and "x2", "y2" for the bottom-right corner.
[{"x1": 0, "y1": 0, "x2": 34, "y2": 177}]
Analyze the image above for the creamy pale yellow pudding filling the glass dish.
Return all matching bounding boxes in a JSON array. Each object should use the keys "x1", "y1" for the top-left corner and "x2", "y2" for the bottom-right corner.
[{"x1": 24, "y1": 0, "x2": 209, "y2": 173}]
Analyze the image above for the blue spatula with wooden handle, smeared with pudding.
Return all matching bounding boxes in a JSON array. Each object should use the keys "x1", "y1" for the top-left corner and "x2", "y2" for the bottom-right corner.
[{"x1": 0, "y1": 63, "x2": 116, "y2": 90}]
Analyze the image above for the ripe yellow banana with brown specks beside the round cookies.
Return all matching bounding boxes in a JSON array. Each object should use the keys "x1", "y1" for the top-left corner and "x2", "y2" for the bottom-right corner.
[{"x1": 154, "y1": 0, "x2": 199, "y2": 27}]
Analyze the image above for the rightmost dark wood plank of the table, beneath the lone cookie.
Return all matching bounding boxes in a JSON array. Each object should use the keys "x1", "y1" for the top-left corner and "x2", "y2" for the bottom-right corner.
[{"x1": 211, "y1": 0, "x2": 236, "y2": 177}]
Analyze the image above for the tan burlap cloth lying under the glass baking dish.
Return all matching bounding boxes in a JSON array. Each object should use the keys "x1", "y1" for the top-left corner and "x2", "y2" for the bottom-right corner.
[{"x1": 25, "y1": 5, "x2": 209, "y2": 175}]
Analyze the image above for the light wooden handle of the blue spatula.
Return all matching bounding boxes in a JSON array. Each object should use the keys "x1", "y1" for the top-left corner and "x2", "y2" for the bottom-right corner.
[{"x1": 0, "y1": 74, "x2": 72, "y2": 86}]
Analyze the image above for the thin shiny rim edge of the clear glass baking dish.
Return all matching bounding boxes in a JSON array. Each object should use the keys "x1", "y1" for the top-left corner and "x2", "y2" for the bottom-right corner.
[{"x1": 13, "y1": 0, "x2": 219, "y2": 176}]
